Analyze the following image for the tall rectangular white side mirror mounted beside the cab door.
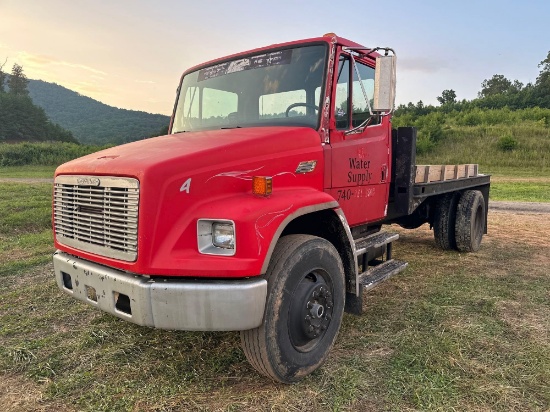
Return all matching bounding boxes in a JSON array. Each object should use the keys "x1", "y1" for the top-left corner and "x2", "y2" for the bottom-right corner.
[{"x1": 373, "y1": 55, "x2": 396, "y2": 112}]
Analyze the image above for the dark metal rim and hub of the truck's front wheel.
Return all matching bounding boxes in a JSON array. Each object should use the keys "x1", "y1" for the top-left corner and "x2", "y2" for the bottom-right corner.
[{"x1": 288, "y1": 269, "x2": 334, "y2": 352}]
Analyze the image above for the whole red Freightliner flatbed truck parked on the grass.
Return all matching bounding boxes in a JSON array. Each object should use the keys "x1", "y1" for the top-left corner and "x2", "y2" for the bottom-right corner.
[{"x1": 53, "y1": 33, "x2": 490, "y2": 383}]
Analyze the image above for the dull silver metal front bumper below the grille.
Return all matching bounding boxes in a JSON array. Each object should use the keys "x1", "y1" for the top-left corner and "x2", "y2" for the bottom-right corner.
[{"x1": 53, "y1": 251, "x2": 267, "y2": 331}]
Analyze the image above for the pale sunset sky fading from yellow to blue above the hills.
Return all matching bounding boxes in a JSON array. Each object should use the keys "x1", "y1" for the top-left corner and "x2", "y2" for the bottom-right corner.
[{"x1": 0, "y1": 0, "x2": 550, "y2": 115}]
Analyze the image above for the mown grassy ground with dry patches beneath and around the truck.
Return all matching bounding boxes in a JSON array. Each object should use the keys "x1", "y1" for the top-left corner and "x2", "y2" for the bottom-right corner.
[{"x1": 0, "y1": 182, "x2": 550, "y2": 411}]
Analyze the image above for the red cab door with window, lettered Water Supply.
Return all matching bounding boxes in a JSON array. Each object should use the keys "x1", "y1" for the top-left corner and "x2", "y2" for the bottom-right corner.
[{"x1": 326, "y1": 53, "x2": 391, "y2": 226}]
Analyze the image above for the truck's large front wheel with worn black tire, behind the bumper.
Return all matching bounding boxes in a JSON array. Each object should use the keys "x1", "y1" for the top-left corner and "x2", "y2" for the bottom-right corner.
[{"x1": 241, "y1": 235, "x2": 345, "y2": 383}]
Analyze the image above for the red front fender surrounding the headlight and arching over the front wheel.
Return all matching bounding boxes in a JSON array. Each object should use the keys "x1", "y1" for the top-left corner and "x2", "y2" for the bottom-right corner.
[{"x1": 151, "y1": 187, "x2": 338, "y2": 277}]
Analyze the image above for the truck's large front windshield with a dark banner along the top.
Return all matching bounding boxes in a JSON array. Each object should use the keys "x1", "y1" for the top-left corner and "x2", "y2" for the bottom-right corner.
[{"x1": 172, "y1": 44, "x2": 327, "y2": 133}]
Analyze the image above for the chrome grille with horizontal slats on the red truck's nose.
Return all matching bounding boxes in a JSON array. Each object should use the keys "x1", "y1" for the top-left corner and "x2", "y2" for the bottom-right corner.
[{"x1": 53, "y1": 176, "x2": 139, "y2": 261}]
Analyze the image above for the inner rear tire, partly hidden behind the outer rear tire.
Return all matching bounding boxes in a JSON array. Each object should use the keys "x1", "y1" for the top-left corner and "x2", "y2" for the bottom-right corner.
[{"x1": 434, "y1": 193, "x2": 460, "y2": 250}]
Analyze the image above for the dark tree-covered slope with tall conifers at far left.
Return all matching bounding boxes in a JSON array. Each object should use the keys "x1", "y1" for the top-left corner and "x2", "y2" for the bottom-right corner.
[{"x1": 0, "y1": 61, "x2": 78, "y2": 143}]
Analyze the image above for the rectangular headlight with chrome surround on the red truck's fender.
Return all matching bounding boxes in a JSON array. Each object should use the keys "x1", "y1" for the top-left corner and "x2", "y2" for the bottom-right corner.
[{"x1": 197, "y1": 219, "x2": 236, "y2": 256}]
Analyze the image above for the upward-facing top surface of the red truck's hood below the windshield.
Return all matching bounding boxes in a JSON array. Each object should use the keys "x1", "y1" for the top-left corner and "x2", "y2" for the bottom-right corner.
[{"x1": 56, "y1": 127, "x2": 321, "y2": 180}]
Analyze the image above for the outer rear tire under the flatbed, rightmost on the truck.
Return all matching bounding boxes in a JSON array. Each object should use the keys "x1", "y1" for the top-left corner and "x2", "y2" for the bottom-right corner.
[{"x1": 455, "y1": 190, "x2": 485, "y2": 252}]
